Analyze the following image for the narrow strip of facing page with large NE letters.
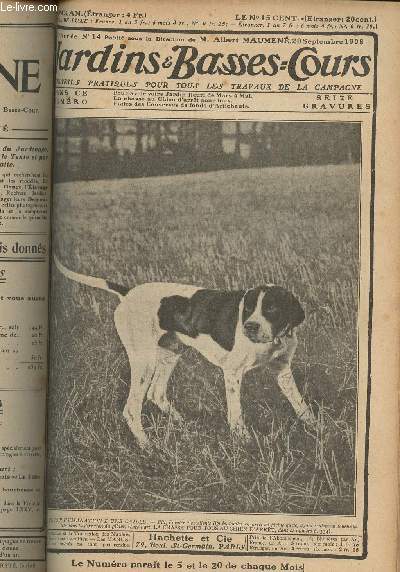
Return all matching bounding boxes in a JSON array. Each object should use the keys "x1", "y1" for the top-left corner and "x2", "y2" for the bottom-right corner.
[{"x1": 0, "y1": 2, "x2": 56, "y2": 571}]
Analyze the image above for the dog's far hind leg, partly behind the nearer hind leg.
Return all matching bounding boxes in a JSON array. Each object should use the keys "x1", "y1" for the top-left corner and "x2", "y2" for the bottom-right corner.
[{"x1": 147, "y1": 347, "x2": 181, "y2": 421}]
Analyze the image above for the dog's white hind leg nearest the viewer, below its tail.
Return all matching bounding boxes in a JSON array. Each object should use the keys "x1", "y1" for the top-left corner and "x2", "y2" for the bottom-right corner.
[{"x1": 115, "y1": 304, "x2": 157, "y2": 448}]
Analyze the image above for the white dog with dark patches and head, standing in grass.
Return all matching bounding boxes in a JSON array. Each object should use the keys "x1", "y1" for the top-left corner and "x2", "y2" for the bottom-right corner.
[{"x1": 54, "y1": 257, "x2": 315, "y2": 447}]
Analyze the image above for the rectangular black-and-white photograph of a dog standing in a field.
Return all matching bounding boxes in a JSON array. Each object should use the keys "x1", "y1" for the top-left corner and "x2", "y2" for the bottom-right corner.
[{"x1": 48, "y1": 118, "x2": 361, "y2": 515}]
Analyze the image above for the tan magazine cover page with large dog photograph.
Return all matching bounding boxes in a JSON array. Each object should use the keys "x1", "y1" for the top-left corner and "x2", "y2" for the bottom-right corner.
[{"x1": 48, "y1": 1, "x2": 399, "y2": 572}]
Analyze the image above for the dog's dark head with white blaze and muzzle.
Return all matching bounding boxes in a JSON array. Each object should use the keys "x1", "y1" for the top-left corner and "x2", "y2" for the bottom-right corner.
[{"x1": 242, "y1": 285, "x2": 304, "y2": 343}]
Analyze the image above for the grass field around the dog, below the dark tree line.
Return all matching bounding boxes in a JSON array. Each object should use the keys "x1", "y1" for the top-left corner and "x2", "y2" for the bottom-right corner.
[{"x1": 49, "y1": 165, "x2": 359, "y2": 514}]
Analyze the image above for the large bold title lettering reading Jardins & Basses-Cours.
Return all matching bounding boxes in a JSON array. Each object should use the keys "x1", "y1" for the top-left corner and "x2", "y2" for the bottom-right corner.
[{"x1": 56, "y1": 41, "x2": 371, "y2": 81}]
